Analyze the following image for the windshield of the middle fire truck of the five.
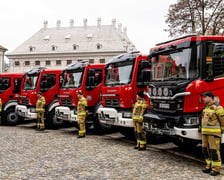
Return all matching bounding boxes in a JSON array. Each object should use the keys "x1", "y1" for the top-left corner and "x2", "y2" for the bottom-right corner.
[{"x1": 62, "y1": 71, "x2": 83, "y2": 88}]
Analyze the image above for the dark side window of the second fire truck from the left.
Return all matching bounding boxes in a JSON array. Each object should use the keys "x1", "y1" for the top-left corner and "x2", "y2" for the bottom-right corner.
[{"x1": 40, "y1": 74, "x2": 56, "y2": 90}]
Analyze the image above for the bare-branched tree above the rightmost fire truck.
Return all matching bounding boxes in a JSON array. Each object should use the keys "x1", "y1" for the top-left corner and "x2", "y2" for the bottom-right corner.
[{"x1": 165, "y1": 0, "x2": 224, "y2": 36}]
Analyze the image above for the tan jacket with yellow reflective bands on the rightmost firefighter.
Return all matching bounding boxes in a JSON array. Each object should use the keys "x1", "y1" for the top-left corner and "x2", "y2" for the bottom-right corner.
[{"x1": 201, "y1": 103, "x2": 224, "y2": 137}]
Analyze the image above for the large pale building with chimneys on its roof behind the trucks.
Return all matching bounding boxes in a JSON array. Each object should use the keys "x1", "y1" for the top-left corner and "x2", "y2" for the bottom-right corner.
[{"x1": 6, "y1": 18, "x2": 136, "y2": 72}]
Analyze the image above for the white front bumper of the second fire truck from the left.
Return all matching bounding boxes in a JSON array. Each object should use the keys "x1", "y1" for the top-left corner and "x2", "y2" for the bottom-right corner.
[{"x1": 16, "y1": 105, "x2": 37, "y2": 119}]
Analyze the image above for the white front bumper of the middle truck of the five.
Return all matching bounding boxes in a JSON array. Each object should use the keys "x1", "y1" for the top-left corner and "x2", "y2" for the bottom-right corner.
[{"x1": 55, "y1": 106, "x2": 78, "y2": 122}]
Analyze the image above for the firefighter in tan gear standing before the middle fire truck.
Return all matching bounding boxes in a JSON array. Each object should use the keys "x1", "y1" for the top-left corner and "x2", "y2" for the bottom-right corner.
[{"x1": 77, "y1": 91, "x2": 87, "y2": 138}]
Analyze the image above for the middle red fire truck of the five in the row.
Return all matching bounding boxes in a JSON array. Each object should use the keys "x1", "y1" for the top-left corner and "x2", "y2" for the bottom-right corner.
[{"x1": 55, "y1": 61, "x2": 105, "y2": 129}]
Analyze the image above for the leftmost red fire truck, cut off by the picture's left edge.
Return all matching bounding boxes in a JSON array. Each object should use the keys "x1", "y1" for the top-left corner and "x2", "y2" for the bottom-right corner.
[{"x1": 0, "y1": 73, "x2": 23, "y2": 125}]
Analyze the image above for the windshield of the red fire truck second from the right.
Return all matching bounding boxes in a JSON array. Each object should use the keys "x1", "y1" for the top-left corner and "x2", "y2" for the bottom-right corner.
[{"x1": 105, "y1": 60, "x2": 134, "y2": 86}]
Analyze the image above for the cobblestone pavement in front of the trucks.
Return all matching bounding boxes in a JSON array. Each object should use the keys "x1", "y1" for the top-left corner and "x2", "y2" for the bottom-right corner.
[{"x1": 0, "y1": 124, "x2": 224, "y2": 180}]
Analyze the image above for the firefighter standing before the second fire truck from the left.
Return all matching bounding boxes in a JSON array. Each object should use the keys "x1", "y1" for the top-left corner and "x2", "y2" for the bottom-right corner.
[{"x1": 36, "y1": 92, "x2": 46, "y2": 131}]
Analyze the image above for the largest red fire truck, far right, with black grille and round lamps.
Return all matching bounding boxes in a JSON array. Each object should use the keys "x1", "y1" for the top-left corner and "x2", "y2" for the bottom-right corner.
[{"x1": 144, "y1": 35, "x2": 224, "y2": 145}]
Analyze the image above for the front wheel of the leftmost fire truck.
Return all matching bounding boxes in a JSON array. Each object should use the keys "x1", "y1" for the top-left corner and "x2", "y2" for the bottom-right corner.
[{"x1": 3, "y1": 108, "x2": 20, "y2": 126}]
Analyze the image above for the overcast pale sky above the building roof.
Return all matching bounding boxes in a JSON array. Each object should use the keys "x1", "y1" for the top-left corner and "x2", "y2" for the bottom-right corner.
[{"x1": 0, "y1": 0, "x2": 177, "y2": 57}]
